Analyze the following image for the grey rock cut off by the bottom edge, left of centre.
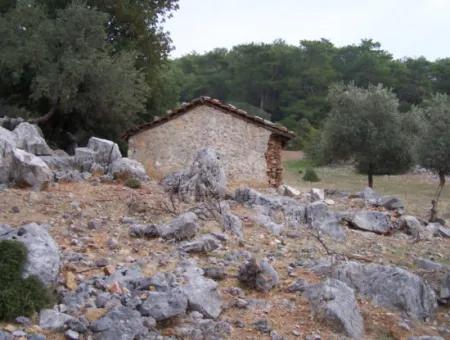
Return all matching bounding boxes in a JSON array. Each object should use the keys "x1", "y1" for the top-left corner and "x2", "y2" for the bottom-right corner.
[{"x1": 94, "y1": 306, "x2": 148, "y2": 340}]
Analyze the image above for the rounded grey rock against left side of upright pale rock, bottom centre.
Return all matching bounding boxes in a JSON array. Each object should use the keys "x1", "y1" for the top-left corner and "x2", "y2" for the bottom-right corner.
[{"x1": 140, "y1": 288, "x2": 188, "y2": 321}]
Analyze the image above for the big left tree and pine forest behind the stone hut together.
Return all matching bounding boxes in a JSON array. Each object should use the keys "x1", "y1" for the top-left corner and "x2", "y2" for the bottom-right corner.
[{"x1": 0, "y1": 0, "x2": 450, "y2": 148}]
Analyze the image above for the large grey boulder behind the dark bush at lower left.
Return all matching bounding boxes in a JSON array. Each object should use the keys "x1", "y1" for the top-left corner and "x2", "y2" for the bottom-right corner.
[{"x1": 0, "y1": 223, "x2": 60, "y2": 285}]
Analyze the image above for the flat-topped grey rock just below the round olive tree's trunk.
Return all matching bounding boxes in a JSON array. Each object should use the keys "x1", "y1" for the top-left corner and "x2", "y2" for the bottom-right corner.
[{"x1": 349, "y1": 210, "x2": 392, "y2": 234}]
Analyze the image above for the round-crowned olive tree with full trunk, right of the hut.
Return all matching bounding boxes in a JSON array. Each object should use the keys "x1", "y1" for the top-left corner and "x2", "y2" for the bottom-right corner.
[{"x1": 322, "y1": 84, "x2": 412, "y2": 188}]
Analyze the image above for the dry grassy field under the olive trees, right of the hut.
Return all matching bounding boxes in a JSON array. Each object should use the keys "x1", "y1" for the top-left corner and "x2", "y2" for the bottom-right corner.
[{"x1": 284, "y1": 159, "x2": 450, "y2": 222}]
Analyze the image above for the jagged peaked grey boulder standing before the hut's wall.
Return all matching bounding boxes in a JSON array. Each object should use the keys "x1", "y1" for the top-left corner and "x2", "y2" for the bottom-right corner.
[{"x1": 161, "y1": 149, "x2": 227, "y2": 201}]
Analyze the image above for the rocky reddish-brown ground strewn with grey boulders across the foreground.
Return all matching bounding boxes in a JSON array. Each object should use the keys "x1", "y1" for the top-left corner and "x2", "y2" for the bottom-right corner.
[{"x1": 0, "y1": 120, "x2": 450, "y2": 340}]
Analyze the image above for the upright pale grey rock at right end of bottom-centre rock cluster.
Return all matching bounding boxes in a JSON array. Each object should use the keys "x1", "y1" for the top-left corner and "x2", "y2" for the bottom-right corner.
[{"x1": 181, "y1": 264, "x2": 222, "y2": 319}]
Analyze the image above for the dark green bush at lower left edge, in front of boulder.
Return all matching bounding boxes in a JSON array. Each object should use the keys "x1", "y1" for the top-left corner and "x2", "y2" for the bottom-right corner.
[{"x1": 0, "y1": 240, "x2": 54, "y2": 321}]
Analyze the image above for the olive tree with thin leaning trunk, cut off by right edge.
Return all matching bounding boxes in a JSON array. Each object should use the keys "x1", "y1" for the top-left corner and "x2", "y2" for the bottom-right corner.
[{"x1": 417, "y1": 94, "x2": 450, "y2": 221}]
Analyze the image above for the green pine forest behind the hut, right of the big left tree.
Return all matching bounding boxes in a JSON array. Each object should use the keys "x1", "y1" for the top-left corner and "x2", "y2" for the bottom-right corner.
[{"x1": 171, "y1": 39, "x2": 450, "y2": 147}]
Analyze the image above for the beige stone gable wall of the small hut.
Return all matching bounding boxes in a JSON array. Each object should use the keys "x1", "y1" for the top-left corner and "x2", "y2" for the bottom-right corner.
[{"x1": 128, "y1": 105, "x2": 276, "y2": 185}]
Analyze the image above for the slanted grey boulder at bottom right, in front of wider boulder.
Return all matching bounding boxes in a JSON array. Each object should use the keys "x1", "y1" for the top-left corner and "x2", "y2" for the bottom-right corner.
[{"x1": 305, "y1": 279, "x2": 364, "y2": 339}]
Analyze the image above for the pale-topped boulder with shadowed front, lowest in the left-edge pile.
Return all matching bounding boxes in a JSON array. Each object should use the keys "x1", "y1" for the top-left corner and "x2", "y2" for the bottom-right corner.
[{"x1": 10, "y1": 149, "x2": 53, "y2": 189}]
